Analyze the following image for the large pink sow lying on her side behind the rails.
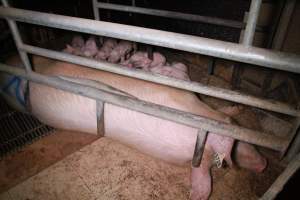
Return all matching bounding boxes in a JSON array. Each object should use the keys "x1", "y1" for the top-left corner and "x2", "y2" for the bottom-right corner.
[{"x1": 30, "y1": 55, "x2": 266, "y2": 200}]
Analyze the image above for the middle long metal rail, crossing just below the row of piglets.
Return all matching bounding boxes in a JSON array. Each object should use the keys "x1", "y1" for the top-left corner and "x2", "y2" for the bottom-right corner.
[{"x1": 22, "y1": 45, "x2": 300, "y2": 116}]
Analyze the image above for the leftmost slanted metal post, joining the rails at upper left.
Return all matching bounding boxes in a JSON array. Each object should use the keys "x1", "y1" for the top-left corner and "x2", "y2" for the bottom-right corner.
[{"x1": 1, "y1": 0, "x2": 32, "y2": 73}]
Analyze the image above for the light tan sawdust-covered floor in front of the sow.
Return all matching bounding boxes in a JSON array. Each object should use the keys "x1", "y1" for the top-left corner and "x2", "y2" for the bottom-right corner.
[{"x1": 4, "y1": 134, "x2": 282, "y2": 200}]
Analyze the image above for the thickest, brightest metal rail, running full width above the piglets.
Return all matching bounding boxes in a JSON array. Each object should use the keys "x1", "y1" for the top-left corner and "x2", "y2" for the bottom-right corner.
[{"x1": 0, "y1": 7, "x2": 300, "y2": 73}]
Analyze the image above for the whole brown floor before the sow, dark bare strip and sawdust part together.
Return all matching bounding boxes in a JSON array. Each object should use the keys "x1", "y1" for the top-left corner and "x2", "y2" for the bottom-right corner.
[{"x1": 0, "y1": 131, "x2": 282, "y2": 200}]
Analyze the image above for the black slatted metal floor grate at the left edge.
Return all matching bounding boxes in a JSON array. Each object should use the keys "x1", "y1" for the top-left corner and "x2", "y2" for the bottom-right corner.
[{"x1": 0, "y1": 98, "x2": 54, "y2": 157}]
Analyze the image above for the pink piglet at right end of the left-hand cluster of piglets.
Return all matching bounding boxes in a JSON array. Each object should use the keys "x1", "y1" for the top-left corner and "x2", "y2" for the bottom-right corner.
[{"x1": 108, "y1": 40, "x2": 134, "y2": 63}]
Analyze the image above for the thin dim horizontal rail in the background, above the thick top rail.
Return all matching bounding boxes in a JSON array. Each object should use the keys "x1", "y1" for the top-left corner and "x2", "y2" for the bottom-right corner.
[{"x1": 94, "y1": 2, "x2": 264, "y2": 31}]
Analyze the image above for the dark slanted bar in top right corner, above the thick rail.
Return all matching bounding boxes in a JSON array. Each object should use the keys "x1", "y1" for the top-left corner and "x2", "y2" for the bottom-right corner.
[{"x1": 272, "y1": 0, "x2": 297, "y2": 50}]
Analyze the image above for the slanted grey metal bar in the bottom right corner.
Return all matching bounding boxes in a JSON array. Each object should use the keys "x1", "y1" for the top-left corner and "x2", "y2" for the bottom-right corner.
[{"x1": 259, "y1": 154, "x2": 300, "y2": 200}]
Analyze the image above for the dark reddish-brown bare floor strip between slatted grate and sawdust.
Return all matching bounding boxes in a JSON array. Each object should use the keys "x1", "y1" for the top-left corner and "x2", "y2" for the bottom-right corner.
[{"x1": 0, "y1": 131, "x2": 97, "y2": 193}]
